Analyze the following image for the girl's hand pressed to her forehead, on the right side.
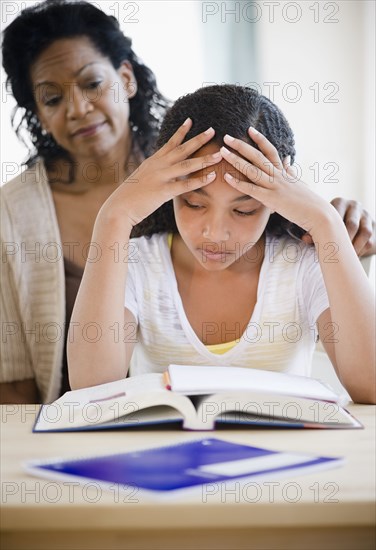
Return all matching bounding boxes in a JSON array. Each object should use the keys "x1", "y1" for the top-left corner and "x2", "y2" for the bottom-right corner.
[{"x1": 221, "y1": 128, "x2": 332, "y2": 236}]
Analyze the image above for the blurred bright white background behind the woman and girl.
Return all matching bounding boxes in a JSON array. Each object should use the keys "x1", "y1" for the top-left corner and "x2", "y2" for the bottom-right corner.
[{"x1": 1, "y1": 0, "x2": 376, "y2": 216}]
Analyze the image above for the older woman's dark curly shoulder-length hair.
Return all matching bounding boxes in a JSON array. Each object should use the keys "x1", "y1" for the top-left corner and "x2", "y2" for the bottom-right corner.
[{"x1": 2, "y1": 0, "x2": 170, "y2": 177}]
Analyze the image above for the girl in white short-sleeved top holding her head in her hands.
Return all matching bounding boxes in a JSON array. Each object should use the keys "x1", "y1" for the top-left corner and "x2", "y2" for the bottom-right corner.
[{"x1": 68, "y1": 86, "x2": 376, "y2": 403}]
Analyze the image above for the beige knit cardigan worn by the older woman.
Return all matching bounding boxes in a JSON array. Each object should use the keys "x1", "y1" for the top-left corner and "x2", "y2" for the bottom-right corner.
[{"x1": 0, "y1": 162, "x2": 65, "y2": 403}]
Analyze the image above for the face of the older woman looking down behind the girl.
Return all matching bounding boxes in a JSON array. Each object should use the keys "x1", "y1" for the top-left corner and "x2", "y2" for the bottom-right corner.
[{"x1": 30, "y1": 37, "x2": 136, "y2": 162}]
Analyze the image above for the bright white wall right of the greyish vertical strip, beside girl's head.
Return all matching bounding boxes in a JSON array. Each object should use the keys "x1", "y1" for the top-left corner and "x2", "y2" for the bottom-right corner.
[{"x1": 256, "y1": 0, "x2": 375, "y2": 215}]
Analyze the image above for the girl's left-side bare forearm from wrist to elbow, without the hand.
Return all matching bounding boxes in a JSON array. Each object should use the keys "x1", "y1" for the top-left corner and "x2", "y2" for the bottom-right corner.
[{"x1": 67, "y1": 213, "x2": 131, "y2": 389}]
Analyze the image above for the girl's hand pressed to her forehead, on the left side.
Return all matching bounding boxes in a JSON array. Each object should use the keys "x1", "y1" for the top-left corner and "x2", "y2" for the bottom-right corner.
[{"x1": 103, "y1": 118, "x2": 223, "y2": 227}]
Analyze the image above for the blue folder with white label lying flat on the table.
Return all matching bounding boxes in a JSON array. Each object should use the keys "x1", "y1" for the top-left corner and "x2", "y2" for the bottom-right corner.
[{"x1": 27, "y1": 438, "x2": 341, "y2": 491}]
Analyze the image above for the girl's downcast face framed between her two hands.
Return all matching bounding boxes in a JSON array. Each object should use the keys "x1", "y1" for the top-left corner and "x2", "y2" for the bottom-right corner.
[{"x1": 173, "y1": 143, "x2": 270, "y2": 271}]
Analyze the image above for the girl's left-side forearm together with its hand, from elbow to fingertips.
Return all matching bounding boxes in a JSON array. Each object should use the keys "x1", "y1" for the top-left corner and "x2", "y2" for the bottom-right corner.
[{"x1": 68, "y1": 122, "x2": 222, "y2": 388}]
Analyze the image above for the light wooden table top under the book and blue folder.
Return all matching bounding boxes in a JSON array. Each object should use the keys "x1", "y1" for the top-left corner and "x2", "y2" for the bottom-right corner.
[{"x1": 0, "y1": 405, "x2": 376, "y2": 550}]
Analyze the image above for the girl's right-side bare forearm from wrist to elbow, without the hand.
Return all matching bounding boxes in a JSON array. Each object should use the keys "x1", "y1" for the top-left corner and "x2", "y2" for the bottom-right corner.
[{"x1": 312, "y1": 208, "x2": 376, "y2": 403}]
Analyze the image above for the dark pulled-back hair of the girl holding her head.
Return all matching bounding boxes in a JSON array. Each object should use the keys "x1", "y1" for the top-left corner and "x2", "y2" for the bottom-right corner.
[{"x1": 133, "y1": 84, "x2": 304, "y2": 238}]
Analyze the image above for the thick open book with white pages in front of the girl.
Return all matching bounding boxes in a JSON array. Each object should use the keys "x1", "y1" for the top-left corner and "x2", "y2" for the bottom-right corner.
[{"x1": 33, "y1": 365, "x2": 362, "y2": 432}]
